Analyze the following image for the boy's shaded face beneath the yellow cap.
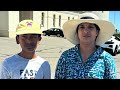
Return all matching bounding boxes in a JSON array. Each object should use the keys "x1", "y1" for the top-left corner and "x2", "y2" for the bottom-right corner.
[{"x1": 16, "y1": 34, "x2": 41, "y2": 52}]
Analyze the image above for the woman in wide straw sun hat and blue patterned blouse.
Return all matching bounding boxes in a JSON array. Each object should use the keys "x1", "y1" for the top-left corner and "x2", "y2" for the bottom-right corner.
[{"x1": 55, "y1": 14, "x2": 116, "y2": 79}]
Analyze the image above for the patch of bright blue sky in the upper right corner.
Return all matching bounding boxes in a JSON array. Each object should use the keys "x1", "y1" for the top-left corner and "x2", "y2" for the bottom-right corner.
[{"x1": 109, "y1": 11, "x2": 120, "y2": 32}]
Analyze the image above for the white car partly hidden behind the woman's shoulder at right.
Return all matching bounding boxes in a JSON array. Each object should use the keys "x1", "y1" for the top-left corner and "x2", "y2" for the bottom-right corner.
[{"x1": 100, "y1": 36, "x2": 120, "y2": 56}]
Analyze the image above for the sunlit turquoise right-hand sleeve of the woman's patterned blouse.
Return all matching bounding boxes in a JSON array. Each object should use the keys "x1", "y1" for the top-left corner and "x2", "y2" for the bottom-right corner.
[{"x1": 104, "y1": 53, "x2": 117, "y2": 79}]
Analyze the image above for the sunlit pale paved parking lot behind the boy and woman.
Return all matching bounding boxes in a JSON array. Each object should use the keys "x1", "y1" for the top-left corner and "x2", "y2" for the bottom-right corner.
[{"x1": 0, "y1": 36, "x2": 120, "y2": 79}]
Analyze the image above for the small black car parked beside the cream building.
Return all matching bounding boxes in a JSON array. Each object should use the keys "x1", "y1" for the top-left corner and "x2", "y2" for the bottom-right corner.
[{"x1": 42, "y1": 28, "x2": 64, "y2": 37}]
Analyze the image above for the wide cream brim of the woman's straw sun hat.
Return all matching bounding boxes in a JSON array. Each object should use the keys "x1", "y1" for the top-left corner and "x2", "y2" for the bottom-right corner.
[{"x1": 63, "y1": 12, "x2": 115, "y2": 45}]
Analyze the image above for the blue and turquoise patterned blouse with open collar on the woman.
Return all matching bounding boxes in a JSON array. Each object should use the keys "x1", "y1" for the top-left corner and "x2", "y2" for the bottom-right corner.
[{"x1": 55, "y1": 44, "x2": 116, "y2": 79}]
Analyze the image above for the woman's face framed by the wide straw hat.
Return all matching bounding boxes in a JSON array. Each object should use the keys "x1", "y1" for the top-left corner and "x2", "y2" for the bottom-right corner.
[{"x1": 78, "y1": 22, "x2": 99, "y2": 44}]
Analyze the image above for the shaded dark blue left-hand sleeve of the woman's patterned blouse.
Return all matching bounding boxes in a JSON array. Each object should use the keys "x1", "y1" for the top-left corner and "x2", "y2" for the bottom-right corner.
[{"x1": 55, "y1": 53, "x2": 66, "y2": 79}]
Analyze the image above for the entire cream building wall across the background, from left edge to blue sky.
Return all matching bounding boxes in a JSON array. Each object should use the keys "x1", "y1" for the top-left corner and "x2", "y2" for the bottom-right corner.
[{"x1": 0, "y1": 11, "x2": 109, "y2": 37}]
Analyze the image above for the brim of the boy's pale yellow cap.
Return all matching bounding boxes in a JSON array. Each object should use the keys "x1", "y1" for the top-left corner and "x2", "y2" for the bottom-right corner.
[{"x1": 16, "y1": 28, "x2": 42, "y2": 35}]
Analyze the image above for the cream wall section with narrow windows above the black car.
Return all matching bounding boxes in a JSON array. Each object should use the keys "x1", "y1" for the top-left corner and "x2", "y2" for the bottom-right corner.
[{"x1": 33, "y1": 11, "x2": 79, "y2": 30}]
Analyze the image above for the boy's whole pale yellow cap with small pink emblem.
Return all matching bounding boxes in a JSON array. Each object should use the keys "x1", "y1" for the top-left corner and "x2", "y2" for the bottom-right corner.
[{"x1": 16, "y1": 20, "x2": 42, "y2": 35}]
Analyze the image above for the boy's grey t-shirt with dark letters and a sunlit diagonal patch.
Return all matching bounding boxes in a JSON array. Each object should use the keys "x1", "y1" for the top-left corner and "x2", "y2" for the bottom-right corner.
[{"x1": 0, "y1": 54, "x2": 51, "y2": 79}]
